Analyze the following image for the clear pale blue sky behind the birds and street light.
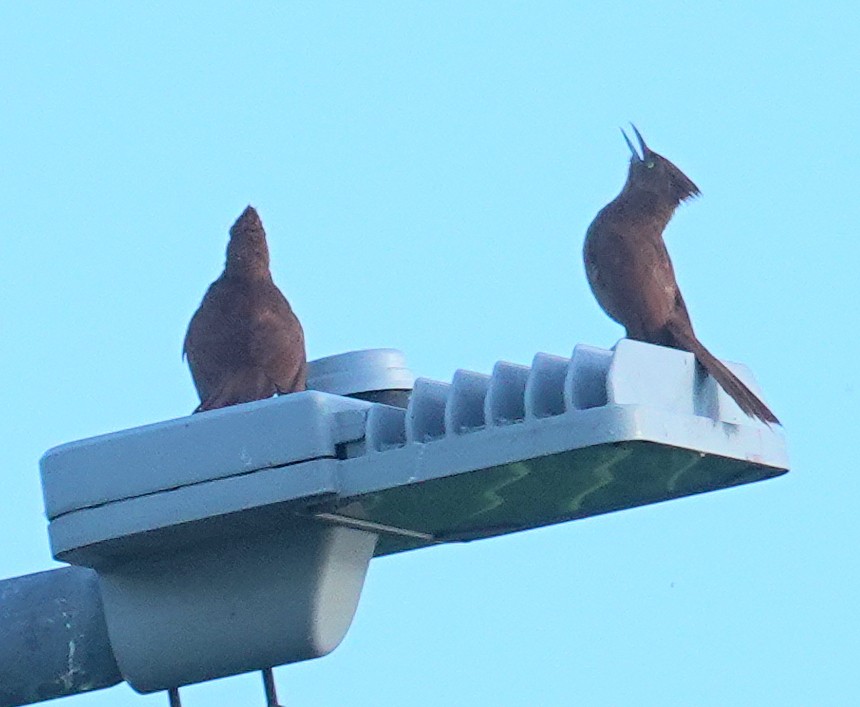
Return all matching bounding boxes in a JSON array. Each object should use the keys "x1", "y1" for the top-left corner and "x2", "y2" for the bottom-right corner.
[{"x1": 0, "y1": 1, "x2": 860, "y2": 707}]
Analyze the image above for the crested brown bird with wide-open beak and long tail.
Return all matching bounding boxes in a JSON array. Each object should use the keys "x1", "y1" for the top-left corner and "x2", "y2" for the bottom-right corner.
[{"x1": 583, "y1": 125, "x2": 779, "y2": 424}]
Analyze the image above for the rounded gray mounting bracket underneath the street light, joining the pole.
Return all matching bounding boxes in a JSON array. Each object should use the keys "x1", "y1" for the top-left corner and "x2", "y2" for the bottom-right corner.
[{"x1": 99, "y1": 520, "x2": 376, "y2": 692}]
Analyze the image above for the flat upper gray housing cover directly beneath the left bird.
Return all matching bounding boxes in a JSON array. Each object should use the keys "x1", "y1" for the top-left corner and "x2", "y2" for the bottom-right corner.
[{"x1": 41, "y1": 391, "x2": 368, "y2": 520}]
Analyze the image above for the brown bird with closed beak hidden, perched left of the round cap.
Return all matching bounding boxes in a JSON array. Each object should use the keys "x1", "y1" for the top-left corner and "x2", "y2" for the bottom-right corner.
[{"x1": 183, "y1": 206, "x2": 307, "y2": 412}]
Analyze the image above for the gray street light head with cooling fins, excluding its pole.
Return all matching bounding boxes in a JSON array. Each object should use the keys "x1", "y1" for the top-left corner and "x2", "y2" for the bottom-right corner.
[{"x1": 42, "y1": 340, "x2": 788, "y2": 690}]
